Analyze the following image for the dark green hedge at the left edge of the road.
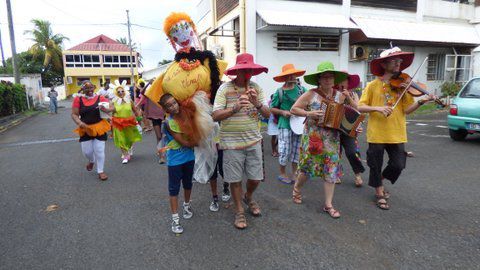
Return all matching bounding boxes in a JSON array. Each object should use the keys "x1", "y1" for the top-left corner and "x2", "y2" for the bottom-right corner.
[{"x1": 0, "y1": 81, "x2": 27, "y2": 116}]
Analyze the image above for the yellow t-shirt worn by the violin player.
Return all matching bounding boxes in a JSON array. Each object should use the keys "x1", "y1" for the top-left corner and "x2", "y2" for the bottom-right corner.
[{"x1": 359, "y1": 78, "x2": 414, "y2": 143}]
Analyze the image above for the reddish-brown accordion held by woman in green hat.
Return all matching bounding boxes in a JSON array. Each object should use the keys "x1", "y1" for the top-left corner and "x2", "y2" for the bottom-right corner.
[{"x1": 317, "y1": 100, "x2": 365, "y2": 137}]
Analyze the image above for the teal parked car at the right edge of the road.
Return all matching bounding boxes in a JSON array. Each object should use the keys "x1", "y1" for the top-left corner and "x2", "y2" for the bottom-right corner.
[{"x1": 447, "y1": 78, "x2": 480, "y2": 141}]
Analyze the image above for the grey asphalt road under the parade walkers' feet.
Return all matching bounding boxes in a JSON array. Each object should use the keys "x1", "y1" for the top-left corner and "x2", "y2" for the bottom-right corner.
[{"x1": 0, "y1": 104, "x2": 480, "y2": 269}]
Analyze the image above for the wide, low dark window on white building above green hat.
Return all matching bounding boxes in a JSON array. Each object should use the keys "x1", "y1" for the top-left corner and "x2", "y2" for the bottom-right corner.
[{"x1": 275, "y1": 33, "x2": 340, "y2": 51}]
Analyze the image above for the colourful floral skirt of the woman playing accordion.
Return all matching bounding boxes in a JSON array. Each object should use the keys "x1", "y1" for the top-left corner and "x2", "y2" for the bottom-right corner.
[{"x1": 298, "y1": 127, "x2": 342, "y2": 183}]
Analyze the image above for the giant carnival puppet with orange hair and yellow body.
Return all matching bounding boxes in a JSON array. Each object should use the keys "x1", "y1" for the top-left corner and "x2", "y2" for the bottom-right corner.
[{"x1": 145, "y1": 12, "x2": 227, "y2": 148}]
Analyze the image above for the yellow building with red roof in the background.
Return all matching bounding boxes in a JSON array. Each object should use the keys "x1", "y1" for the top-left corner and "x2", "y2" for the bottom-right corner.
[{"x1": 63, "y1": 35, "x2": 138, "y2": 95}]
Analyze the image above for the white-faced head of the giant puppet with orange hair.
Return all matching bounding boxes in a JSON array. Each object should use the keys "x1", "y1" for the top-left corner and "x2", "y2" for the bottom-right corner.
[{"x1": 163, "y1": 12, "x2": 202, "y2": 52}]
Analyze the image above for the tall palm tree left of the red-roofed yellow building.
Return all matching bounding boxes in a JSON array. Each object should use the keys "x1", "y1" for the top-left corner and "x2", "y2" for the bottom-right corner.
[{"x1": 25, "y1": 19, "x2": 69, "y2": 70}]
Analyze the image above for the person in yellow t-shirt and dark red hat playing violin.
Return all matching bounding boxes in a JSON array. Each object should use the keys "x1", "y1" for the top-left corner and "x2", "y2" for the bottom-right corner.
[{"x1": 358, "y1": 47, "x2": 435, "y2": 210}]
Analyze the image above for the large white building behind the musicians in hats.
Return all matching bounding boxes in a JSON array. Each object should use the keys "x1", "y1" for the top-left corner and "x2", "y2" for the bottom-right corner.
[{"x1": 196, "y1": 0, "x2": 480, "y2": 97}]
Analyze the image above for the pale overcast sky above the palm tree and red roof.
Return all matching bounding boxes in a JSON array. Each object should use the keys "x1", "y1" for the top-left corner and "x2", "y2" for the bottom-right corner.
[{"x1": 0, "y1": 0, "x2": 198, "y2": 69}]
